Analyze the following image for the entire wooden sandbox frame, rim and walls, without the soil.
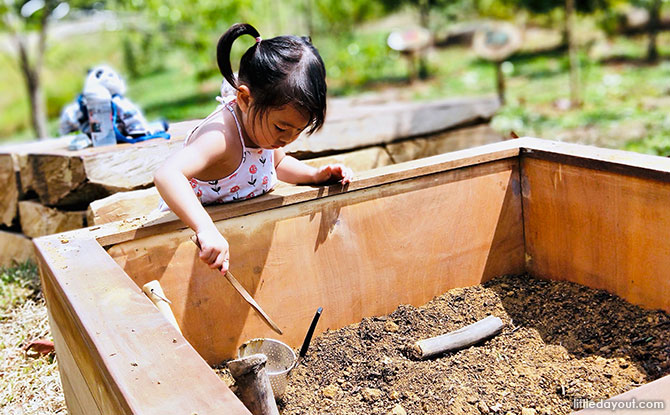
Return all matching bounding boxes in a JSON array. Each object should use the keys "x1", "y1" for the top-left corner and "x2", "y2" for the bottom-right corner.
[{"x1": 34, "y1": 138, "x2": 670, "y2": 415}]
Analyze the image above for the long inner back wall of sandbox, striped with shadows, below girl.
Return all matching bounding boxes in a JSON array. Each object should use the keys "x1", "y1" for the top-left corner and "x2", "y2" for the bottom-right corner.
[{"x1": 108, "y1": 157, "x2": 524, "y2": 363}]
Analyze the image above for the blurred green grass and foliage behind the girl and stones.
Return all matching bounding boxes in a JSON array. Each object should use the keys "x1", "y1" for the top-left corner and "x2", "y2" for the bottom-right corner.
[{"x1": 0, "y1": 0, "x2": 670, "y2": 154}]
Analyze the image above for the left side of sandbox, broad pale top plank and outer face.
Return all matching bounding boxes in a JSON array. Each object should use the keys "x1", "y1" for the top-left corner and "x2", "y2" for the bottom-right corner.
[{"x1": 35, "y1": 238, "x2": 249, "y2": 415}]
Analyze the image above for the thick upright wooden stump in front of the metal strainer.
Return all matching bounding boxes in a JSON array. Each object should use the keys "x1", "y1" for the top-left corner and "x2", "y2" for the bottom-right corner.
[{"x1": 228, "y1": 353, "x2": 279, "y2": 415}]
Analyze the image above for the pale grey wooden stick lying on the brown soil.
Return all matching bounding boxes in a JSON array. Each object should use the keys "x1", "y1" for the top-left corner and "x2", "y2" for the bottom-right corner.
[{"x1": 409, "y1": 316, "x2": 503, "y2": 359}]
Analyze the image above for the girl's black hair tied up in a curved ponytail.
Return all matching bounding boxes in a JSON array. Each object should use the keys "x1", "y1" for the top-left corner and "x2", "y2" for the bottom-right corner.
[{"x1": 216, "y1": 23, "x2": 326, "y2": 134}]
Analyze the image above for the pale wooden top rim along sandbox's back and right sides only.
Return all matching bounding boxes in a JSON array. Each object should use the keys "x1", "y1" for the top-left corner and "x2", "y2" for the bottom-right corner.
[{"x1": 50, "y1": 137, "x2": 670, "y2": 247}]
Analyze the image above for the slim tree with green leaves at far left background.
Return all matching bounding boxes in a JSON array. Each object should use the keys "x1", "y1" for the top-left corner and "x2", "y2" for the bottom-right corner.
[{"x1": 0, "y1": 0, "x2": 70, "y2": 139}]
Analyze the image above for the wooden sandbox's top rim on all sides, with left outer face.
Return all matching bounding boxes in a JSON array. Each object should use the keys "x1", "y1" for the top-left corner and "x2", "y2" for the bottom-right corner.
[{"x1": 34, "y1": 138, "x2": 670, "y2": 414}]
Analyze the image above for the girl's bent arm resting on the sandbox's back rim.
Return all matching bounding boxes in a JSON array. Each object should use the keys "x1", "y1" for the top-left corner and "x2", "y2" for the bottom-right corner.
[{"x1": 274, "y1": 148, "x2": 354, "y2": 184}]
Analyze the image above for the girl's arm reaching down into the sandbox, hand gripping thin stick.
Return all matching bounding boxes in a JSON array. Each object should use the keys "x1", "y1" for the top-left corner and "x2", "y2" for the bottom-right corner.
[{"x1": 154, "y1": 127, "x2": 229, "y2": 272}]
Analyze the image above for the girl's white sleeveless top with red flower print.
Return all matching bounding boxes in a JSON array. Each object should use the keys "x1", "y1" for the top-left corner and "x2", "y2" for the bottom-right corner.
[{"x1": 159, "y1": 100, "x2": 277, "y2": 211}]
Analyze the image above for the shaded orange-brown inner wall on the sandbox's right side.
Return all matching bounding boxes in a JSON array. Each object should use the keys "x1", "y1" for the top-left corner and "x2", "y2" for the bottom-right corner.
[{"x1": 521, "y1": 155, "x2": 670, "y2": 311}]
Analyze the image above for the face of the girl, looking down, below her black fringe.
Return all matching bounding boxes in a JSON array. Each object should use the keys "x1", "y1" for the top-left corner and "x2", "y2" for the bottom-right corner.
[{"x1": 245, "y1": 105, "x2": 310, "y2": 149}]
